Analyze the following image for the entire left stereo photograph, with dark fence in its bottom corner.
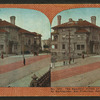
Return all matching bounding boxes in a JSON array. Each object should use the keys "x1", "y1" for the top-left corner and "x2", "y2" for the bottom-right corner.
[{"x1": 0, "y1": 8, "x2": 51, "y2": 87}]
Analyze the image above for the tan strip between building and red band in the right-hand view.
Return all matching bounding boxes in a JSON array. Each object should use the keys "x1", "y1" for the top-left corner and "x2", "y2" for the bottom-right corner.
[{"x1": 52, "y1": 55, "x2": 100, "y2": 71}]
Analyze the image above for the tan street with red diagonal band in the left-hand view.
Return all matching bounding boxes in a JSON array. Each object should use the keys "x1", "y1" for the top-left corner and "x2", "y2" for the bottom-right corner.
[{"x1": 0, "y1": 55, "x2": 50, "y2": 87}]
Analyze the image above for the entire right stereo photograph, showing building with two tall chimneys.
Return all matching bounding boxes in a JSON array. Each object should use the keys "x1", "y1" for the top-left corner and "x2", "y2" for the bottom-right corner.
[{"x1": 51, "y1": 8, "x2": 100, "y2": 87}]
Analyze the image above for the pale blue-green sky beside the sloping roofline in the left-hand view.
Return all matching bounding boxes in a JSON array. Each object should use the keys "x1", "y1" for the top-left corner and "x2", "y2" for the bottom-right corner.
[{"x1": 0, "y1": 8, "x2": 50, "y2": 40}]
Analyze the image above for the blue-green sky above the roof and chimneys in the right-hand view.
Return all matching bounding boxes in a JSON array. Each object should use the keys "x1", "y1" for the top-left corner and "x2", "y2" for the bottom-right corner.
[{"x1": 52, "y1": 8, "x2": 100, "y2": 27}]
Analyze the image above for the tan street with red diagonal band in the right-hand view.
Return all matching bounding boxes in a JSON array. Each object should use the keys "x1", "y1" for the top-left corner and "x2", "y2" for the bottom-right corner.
[{"x1": 51, "y1": 55, "x2": 100, "y2": 87}]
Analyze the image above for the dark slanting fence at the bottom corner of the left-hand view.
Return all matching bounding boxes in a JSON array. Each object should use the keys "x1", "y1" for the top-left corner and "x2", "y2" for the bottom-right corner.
[{"x1": 30, "y1": 69, "x2": 51, "y2": 87}]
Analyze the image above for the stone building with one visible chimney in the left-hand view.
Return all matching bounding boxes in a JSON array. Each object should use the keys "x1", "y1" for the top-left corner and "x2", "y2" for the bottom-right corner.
[{"x1": 0, "y1": 16, "x2": 41, "y2": 54}]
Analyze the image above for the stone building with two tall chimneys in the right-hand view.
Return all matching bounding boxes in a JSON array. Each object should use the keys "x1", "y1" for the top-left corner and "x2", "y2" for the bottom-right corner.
[{"x1": 51, "y1": 15, "x2": 100, "y2": 60}]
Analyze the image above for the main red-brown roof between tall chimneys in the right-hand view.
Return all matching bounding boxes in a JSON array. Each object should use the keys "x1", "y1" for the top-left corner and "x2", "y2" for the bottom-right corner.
[{"x1": 52, "y1": 20, "x2": 100, "y2": 29}]
